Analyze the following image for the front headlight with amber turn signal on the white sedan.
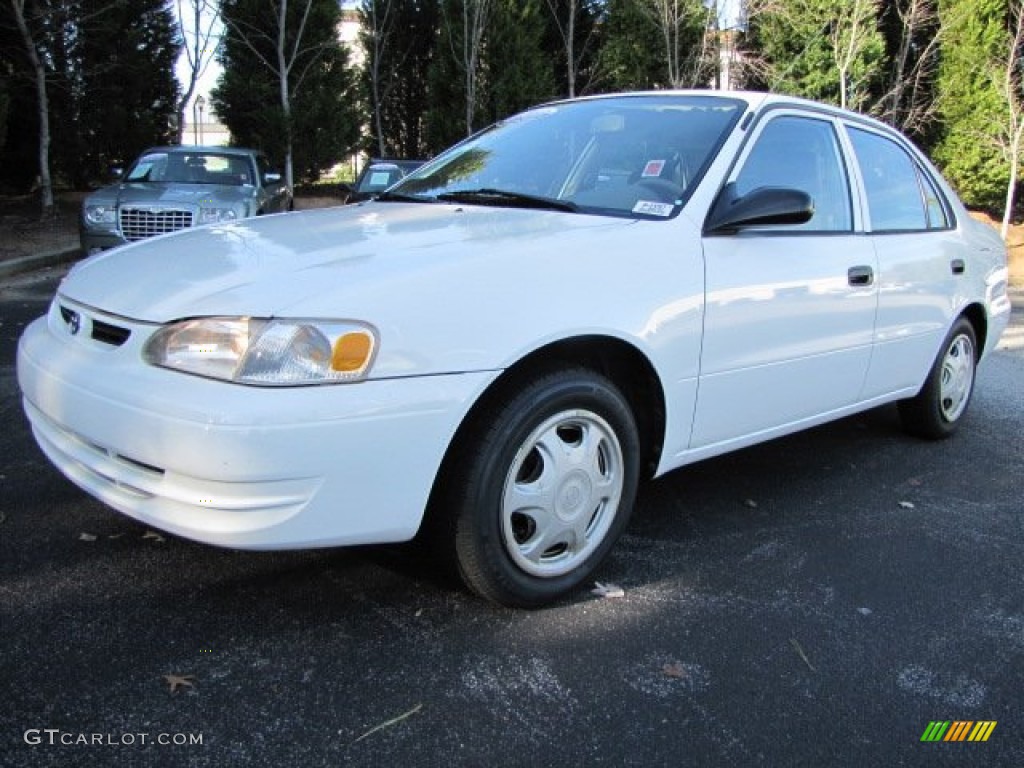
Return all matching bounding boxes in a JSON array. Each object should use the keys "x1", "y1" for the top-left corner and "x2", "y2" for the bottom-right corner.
[{"x1": 142, "y1": 317, "x2": 377, "y2": 386}]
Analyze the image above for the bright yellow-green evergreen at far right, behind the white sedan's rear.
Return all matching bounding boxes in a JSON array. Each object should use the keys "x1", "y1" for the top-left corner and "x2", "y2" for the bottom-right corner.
[{"x1": 934, "y1": 0, "x2": 1010, "y2": 211}]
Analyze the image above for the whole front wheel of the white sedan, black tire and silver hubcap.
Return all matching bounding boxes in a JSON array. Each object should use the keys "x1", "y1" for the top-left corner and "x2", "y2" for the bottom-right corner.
[{"x1": 435, "y1": 368, "x2": 640, "y2": 607}]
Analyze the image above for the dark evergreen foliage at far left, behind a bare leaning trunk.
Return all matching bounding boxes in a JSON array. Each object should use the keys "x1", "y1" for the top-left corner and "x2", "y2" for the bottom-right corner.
[{"x1": 0, "y1": 0, "x2": 179, "y2": 188}]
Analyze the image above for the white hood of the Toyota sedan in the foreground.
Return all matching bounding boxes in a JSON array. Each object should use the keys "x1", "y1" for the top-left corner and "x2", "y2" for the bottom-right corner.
[{"x1": 59, "y1": 203, "x2": 634, "y2": 323}]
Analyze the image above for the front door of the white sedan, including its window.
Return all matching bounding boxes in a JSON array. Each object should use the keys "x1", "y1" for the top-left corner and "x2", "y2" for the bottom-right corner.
[{"x1": 690, "y1": 111, "x2": 878, "y2": 451}]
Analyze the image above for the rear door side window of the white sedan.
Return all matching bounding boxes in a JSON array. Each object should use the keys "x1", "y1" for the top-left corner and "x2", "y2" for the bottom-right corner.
[{"x1": 850, "y1": 127, "x2": 949, "y2": 232}]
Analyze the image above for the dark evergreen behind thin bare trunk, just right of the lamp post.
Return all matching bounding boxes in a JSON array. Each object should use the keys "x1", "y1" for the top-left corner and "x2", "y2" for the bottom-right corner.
[{"x1": 210, "y1": 0, "x2": 359, "y2": 180}]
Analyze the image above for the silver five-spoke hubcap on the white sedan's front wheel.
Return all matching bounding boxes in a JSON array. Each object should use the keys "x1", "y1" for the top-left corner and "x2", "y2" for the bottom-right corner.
[{"x1": 502, "y1": 411, "x2": 623, "y2": 579}]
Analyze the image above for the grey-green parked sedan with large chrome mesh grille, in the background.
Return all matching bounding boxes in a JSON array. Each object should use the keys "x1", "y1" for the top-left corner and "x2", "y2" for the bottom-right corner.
[{"x1": 79, "y1": 146, "x2": 292, "y2": 253}]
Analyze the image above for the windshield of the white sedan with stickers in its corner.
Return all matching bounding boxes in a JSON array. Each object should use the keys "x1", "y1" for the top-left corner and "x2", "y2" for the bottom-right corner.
[{"x1": 385, "y1": 94, "x2": 745, "y2": 218}]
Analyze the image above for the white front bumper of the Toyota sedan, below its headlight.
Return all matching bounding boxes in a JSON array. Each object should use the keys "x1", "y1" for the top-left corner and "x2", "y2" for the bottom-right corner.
[{"x1": 17, "y1": 299, "x2": 497, "y2": 549}]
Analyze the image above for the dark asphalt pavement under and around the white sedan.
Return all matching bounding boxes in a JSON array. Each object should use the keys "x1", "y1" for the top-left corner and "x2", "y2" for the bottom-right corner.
[{"x1": 0, "y1": 269, "x2": 1024, "y2": 768}]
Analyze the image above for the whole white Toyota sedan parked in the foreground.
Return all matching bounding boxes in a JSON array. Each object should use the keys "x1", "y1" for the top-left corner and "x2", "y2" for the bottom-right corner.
[{"x1": 17, "y1": 92, "x2": 1010, "y2": 606}]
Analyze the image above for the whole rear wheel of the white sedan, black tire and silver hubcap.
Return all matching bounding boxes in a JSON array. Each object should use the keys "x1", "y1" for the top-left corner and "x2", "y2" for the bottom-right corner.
[{"x1": 899, "y1": 316, "x2": 978, "y2": 440}]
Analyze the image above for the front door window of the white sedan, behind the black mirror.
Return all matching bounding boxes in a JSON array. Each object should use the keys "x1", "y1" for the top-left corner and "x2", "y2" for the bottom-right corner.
[{"x1": 736, "y1": 115, "x2": 853, "y2": 231}]
